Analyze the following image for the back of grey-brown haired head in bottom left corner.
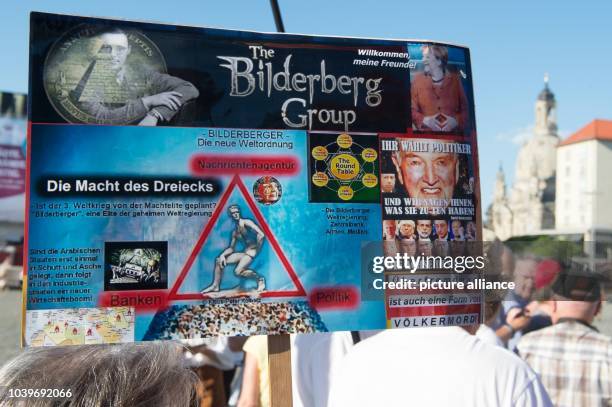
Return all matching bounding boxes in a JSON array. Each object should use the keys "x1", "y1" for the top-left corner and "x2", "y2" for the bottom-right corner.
[{"x1": 0, "y1": 342, "x2": 197, "y2": 407}]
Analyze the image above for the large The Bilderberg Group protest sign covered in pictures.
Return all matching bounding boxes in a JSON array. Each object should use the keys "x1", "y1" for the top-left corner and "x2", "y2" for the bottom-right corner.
[{"x1": 24, "y1": 13, "x2": 480, "y2": 346}]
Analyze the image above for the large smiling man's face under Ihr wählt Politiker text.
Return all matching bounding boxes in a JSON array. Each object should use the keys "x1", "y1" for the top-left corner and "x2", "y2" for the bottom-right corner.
[{"x1": 392, "y1": 140, "x2": 459, "y2": 206}]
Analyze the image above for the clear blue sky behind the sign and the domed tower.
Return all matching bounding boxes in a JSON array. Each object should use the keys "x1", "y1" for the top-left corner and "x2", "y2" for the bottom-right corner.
[{"x1": 0, "y1": 0, "x2": 612, "y2": 208}]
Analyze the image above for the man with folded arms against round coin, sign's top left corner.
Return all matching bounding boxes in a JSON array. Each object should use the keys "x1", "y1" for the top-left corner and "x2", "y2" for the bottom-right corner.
[{"x1": 45, "y1": 27, "x2": 199, "y2": 126}]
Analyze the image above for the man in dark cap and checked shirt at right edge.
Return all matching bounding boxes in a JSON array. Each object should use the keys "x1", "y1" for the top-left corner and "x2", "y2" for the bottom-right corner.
[{"x1": 518, "y1": 265, "x2": 612, "y2": 406}]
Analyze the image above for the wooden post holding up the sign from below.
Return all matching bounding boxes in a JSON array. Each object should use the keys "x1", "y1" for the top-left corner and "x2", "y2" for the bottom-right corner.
[{"x1": 268, "y1": 335, "x2": 293, "y2": 407}]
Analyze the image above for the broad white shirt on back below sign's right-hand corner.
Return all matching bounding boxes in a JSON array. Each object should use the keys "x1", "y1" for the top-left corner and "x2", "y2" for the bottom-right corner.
[{"x1": 329, "y1": 327, "x2": 552, "y2": 407}]
